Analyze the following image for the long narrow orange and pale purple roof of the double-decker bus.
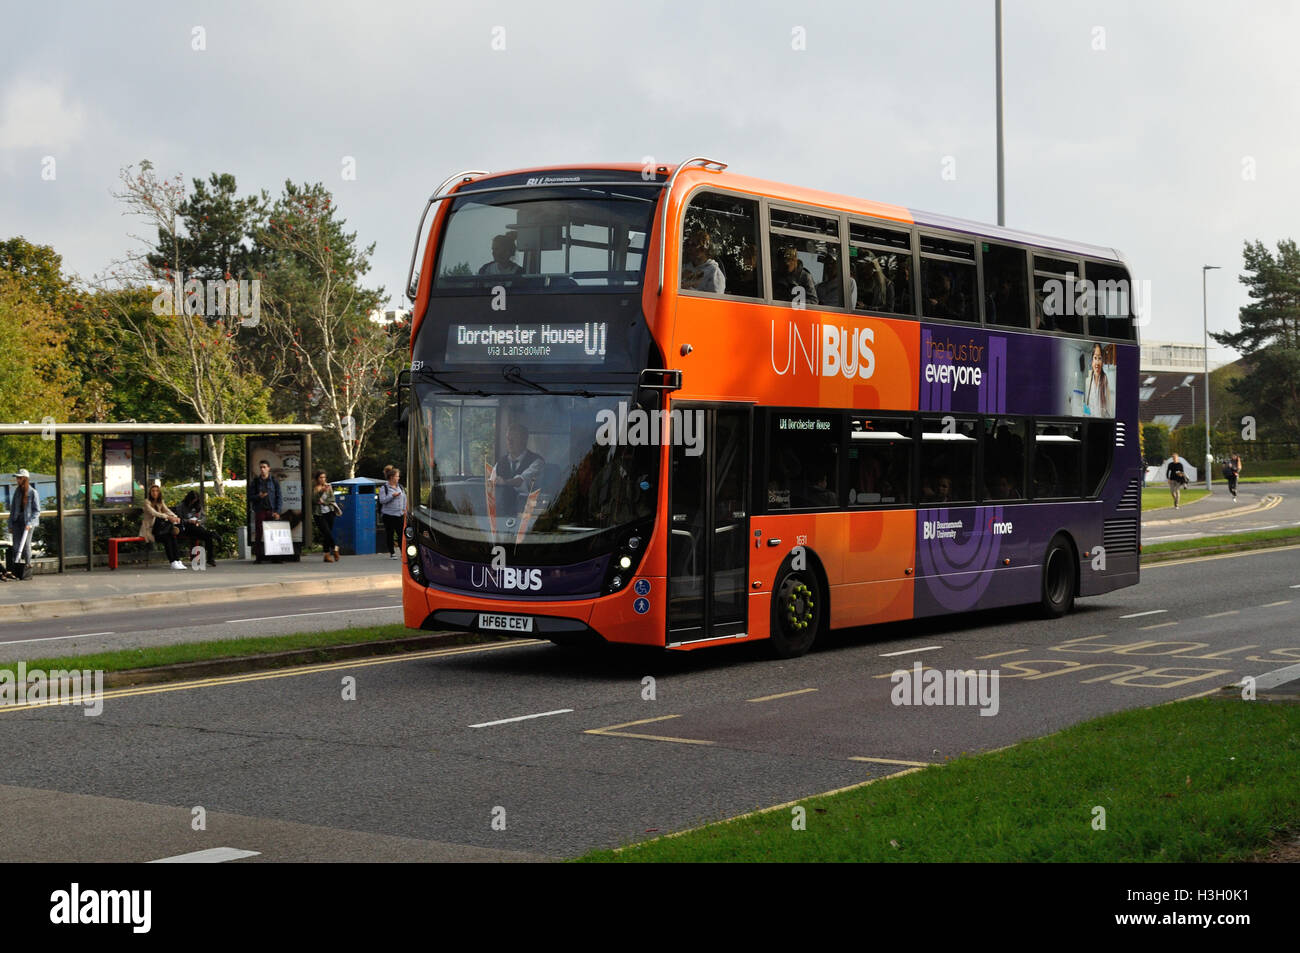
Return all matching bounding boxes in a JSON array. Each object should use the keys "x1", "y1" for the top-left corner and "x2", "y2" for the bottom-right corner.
[{"x1": 462, "y1": 163, "x2": 1123, "y2": 261}]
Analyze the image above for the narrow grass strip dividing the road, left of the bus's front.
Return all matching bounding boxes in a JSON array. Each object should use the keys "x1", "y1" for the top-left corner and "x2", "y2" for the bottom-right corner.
[{"x1": 0, "y1": 625, "x2": 493, "y2": 672}]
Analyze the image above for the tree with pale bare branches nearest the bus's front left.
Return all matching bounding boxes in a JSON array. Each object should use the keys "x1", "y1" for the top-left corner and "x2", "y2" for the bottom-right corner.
[{"x1": 257, "y1": 182, "x2": 400, "y2": 477}]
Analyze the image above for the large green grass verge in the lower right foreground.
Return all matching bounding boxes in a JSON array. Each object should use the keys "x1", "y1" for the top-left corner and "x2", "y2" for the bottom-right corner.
[{"x1": 577, "y1": 698, "x2": 1300, "y2": 863}]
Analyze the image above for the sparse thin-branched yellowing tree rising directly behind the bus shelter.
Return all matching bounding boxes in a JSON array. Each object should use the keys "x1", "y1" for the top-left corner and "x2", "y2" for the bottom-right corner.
[{"x1": 100, "y1": 160, "x2": 269, "y2": 494}]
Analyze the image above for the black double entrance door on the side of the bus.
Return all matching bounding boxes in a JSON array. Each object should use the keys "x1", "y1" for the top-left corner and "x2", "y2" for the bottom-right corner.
[{"x1": 667, "y1": 403, "x2": 751, "y2": 645}]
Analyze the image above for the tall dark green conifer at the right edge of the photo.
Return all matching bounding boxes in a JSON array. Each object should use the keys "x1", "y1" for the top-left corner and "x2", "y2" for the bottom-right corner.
[{"x1": 1213, "y1": 239, "x2": 1300, "y2": 441}]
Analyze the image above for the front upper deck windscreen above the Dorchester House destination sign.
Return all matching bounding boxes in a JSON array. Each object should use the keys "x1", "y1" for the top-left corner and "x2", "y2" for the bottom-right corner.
[{"x1": 433, "y1": 183, "x2": 659, "y2": 294}]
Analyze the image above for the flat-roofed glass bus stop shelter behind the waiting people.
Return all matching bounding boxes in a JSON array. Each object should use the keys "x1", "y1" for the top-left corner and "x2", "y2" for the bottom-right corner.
[{"x1": 0, "y1": 421, "x2": 325, "y2": 572}]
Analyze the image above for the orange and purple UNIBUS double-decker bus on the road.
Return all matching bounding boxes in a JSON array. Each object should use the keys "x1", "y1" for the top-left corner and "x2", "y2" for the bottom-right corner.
[{"x1": 403, "y1": 157, "x2": 1140, "y2": 658}]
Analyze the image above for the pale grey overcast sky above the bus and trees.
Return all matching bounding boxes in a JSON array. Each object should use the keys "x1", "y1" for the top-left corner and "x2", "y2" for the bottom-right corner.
[{"x1": 0, "y1": 0, "x2": 1300, "y2": 358}]
